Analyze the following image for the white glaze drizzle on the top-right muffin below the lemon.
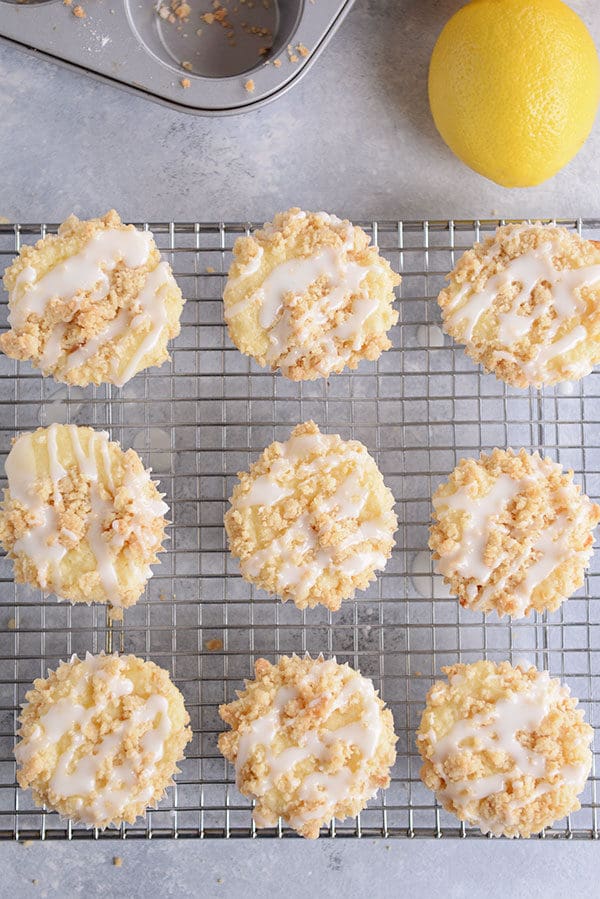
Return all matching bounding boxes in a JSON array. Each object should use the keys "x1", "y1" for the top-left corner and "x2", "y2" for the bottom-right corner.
[{"x1": 447, "y1": 227, "x2": 600, "y2": 381}]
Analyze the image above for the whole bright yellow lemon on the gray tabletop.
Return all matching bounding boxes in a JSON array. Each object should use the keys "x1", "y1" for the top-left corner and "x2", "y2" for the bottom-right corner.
[{"x1": 429, "y1": 0, "x2": 600, "y2": 187}]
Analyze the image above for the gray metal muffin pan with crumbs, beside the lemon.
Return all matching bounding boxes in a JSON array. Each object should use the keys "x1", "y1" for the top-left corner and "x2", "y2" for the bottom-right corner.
[{"x1": 0, "y1": 0, "x2": 354, "y2": 115}]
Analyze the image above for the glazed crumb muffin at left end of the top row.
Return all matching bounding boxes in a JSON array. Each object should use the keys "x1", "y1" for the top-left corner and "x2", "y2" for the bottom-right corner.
[{"x1": 0, "y1": 209, "x2": 184, "y2": 387}]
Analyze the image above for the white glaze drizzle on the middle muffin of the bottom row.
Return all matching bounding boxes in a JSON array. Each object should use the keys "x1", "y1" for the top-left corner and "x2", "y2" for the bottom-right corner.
[{"x1": 235, "y1": 660, "x2": 381, "y2": 828}]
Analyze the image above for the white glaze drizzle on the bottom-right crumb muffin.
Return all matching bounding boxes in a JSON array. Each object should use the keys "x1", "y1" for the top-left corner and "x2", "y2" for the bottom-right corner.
[{"x1": 429, "y1": 671, "x2": 587, "y2": 834}]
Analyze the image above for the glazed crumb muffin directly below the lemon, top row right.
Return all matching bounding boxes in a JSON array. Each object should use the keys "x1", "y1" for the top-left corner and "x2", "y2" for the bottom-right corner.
[{"x1": 438, "y1": 224, "x2": 600, "y2": 387}]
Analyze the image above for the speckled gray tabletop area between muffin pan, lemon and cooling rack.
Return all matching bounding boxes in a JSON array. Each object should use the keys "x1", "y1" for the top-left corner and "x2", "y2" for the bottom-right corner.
[{"x1": 0, "y1": 0, "x2": 600, "y2": 221}]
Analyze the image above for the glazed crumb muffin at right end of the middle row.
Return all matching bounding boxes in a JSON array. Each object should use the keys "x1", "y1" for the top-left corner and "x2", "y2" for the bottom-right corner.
[{"x1": 429, "y1": 449, "x2": 600, "y2": 618}]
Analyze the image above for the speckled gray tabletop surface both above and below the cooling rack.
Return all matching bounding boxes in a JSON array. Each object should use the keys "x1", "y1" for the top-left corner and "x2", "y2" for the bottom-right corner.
[{"x1": 0, "y1": 0, "x2": 600, "y2": 899}]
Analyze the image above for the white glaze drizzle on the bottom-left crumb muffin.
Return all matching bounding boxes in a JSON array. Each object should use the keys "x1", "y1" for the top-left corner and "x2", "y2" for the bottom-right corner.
[{"x1": 15, "y1": 653, "x2": 171, "y2": 826}]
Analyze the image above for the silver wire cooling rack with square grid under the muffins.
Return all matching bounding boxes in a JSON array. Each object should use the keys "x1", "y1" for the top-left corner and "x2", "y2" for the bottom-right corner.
[{"x1": 0, "y1": 221, "x2": 600, "y2": 839}]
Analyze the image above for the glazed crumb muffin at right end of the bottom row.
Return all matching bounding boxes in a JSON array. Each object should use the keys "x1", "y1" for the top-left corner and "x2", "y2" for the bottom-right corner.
[{"x1": 417, "y1": 661, "x2": 593, "y2": 837}]
